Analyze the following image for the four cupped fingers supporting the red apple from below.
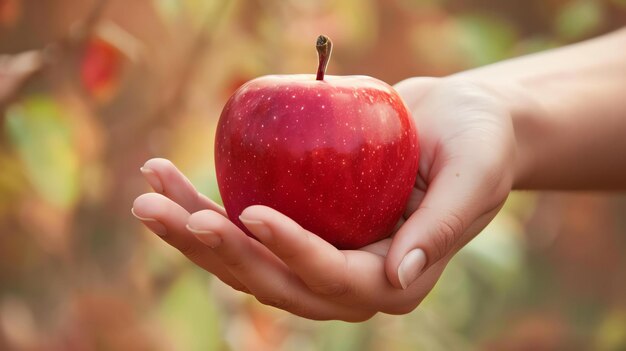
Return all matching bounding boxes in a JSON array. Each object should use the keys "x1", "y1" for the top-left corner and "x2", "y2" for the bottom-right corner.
[{"x1": 132, "y1": 159, "x2": 443, "y2": 322}]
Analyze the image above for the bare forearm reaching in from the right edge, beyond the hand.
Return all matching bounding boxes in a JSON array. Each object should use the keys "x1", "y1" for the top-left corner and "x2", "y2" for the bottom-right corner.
[{"x1": 455, "y1": 29, "x2": 626, "y2": 189}]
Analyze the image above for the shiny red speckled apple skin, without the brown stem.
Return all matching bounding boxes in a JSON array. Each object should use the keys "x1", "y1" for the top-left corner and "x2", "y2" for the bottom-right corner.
[{"x1": 215, "y1": 74, "x2": 419, "y2": 249}]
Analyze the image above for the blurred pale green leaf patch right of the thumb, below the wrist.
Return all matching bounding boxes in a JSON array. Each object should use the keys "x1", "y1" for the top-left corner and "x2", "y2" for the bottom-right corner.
[{"x1": 422, "y1": 206, "x2": 526, "y2": 338}]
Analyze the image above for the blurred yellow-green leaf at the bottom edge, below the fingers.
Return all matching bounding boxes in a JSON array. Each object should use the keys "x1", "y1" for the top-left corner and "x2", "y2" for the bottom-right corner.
[{"x1": 157, "y1": 269, "x2": 225, "y2": 351}]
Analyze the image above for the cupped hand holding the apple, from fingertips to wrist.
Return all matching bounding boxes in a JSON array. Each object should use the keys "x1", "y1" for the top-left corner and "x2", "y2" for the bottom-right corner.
[{"x1": 133, "y1": 36, "x2": 515, "y2": 321}]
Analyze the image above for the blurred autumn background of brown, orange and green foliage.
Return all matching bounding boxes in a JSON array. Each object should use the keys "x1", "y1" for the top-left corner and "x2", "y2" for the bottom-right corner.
[{"x1": 0, "y1": 0, "x2": 626, "y2": 351}]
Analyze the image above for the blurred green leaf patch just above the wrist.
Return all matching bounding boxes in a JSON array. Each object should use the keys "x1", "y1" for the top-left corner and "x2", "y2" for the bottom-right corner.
[{"x1": 457, "y1": 14, "x2": 517, "y2": 66}]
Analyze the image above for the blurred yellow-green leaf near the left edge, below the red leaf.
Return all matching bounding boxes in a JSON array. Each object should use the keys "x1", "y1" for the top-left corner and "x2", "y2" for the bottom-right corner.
[{"x1": 6, "y1": 96, "x2": 79, "y2": 208}]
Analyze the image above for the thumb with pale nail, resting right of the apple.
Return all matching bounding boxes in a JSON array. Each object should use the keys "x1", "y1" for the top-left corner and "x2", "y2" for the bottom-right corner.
[{"x1": 385, "y1": 164, "x2": 504, "y2": 289}]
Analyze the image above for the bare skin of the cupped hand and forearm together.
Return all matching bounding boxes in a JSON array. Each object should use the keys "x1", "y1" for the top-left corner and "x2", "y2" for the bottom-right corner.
[{"x1": 133, "y1": 30, "x2": 626, "y2": 322}]
